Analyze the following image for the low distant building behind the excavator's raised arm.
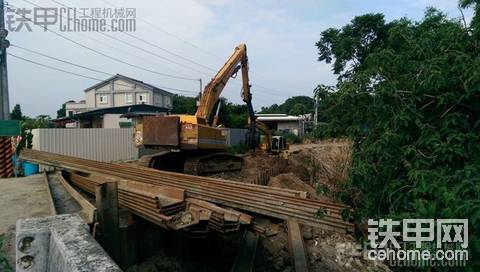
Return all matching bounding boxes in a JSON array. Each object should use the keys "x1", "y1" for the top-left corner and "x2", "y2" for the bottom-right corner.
[{"x1": 256, "y1": 113, "x2": 306, "y2": 137}]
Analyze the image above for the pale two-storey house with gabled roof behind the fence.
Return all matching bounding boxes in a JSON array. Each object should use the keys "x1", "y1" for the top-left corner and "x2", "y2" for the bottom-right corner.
[{"x1": 58, "y1": 74, "x2": 174, "y2": 128}]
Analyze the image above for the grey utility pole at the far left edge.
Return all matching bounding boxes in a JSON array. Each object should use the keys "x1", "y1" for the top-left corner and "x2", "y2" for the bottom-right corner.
[{"x1": 0, "y1": 0, "x2": 10, "y2": 120}]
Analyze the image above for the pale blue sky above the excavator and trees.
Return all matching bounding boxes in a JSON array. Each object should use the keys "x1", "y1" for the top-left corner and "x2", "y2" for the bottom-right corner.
[{"x1": 8, "y1": 0, "x2": 472, "y2": 117}]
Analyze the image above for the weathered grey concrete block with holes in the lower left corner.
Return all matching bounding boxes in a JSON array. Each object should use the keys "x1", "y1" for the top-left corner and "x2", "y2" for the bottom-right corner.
[{"x1": 16, "y1": 214, "x2": 121, "y2": 272}]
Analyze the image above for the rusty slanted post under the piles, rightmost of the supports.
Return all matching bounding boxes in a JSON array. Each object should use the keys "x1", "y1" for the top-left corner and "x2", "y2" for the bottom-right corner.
[{"x1": 287, "y1": 221, "x2": 308, "y2": 272}]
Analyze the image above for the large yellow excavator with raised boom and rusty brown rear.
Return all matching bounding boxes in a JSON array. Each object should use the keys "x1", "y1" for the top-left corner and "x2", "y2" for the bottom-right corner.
[{"x1": 135, "y1": 44, "x2": 284, "y2": 175}]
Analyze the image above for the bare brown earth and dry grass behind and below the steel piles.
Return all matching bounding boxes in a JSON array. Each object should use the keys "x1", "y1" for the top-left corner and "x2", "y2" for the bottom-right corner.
[{"x1": 129, "y1": 140, "x2": 390, "y2": 272}]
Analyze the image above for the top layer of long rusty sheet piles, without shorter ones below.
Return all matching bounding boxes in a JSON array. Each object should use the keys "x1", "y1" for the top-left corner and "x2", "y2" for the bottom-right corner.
[{"x1": 21, "y1": 150, "x2": 353, "y2": 232}]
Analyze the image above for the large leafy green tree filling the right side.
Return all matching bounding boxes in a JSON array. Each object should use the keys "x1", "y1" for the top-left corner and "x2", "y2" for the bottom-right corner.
[{"x1": 316, "y1": 3, "x2": 480, "y2": 271}]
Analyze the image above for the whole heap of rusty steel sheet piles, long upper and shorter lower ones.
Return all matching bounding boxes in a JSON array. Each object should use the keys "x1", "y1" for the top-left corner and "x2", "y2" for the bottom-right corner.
[{"x1": 21, "y1": 150, "x2": 353, "y2": 232}]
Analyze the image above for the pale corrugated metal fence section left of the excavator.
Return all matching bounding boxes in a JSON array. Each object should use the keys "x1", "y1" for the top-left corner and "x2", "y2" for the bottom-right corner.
[{"x1": 32, "y1": 128, "x2": 138, "y2": 162}]
